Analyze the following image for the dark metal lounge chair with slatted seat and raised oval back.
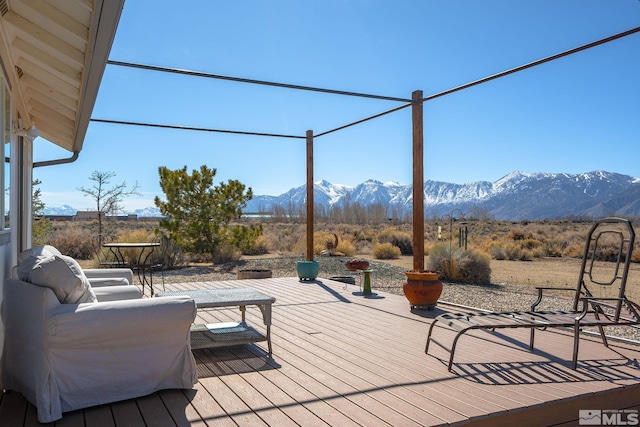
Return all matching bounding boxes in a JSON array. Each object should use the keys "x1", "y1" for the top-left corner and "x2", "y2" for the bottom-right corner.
[{"x1": 425, "y1": 218, "x2": 640, "y2": 371}]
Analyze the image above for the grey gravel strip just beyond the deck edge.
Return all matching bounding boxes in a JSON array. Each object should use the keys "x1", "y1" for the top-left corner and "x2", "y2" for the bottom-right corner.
[{"x1": 164, "y1": 256, "x2": 640, "y2": 341}]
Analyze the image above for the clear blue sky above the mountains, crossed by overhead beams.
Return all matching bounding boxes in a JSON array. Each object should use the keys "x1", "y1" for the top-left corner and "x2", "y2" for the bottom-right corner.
[{"x1": 34, "y1": 0, "x2": 640, "y2": 210}]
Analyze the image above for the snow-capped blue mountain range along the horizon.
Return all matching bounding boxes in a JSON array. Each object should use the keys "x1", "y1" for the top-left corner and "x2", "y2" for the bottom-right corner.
[{"x1": 45, "y1": 170, "x2": 640, "y2": 221}]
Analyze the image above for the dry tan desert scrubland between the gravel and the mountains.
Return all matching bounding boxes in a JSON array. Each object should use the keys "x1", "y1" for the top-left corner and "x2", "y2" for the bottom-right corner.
[{"x1": 55, "y1": 220, "x2": 640, "y2": 301}]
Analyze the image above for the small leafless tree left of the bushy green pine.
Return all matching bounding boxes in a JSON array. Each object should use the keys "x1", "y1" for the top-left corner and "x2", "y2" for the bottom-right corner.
[{"x1": 78, "y1": 171, "x2": 140, "y2": 244}]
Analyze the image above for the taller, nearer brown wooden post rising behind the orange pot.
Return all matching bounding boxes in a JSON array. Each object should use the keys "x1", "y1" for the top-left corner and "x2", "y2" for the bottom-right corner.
[{"x1": 411, "y1": 90, "x2": 424, "y2": 270}]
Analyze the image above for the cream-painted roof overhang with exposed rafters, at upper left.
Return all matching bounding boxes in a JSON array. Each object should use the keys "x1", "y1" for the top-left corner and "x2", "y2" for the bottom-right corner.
[{"x1": 0, "y1": 0, "x2": 124, "y2": 153}]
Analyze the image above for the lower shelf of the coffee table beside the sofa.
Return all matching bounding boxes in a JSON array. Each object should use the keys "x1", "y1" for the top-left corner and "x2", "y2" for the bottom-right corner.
[{"x1": 191, "y1": 322, "x2": 267, "y2": 350}]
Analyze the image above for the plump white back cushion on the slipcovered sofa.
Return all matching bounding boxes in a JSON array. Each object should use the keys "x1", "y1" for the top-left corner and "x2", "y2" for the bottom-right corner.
[{"x1": 27, "y1": 255, "x2": 98, "y2": 304}]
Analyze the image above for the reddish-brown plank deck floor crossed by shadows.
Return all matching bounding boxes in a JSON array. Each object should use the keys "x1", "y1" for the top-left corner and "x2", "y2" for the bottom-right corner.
[{"x1": 0, "y1": 277, "x2": 640, "y2": 427}]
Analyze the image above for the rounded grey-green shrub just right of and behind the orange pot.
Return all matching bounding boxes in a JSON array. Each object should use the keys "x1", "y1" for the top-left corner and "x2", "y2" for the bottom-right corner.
[{"x1": 427, "y1": 245, "x2": 491, "y2": 284}]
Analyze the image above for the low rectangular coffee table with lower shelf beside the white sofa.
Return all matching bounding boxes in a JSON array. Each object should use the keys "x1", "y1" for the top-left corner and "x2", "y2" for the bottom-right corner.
[{"x1": 158, "y1": 288, "x2": 276, "y2": 356}]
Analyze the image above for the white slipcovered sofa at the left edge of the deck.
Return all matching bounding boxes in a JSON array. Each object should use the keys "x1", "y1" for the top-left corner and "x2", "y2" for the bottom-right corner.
[{"x1": 2, "y1": 247, "x2": 197, "y2": 423}]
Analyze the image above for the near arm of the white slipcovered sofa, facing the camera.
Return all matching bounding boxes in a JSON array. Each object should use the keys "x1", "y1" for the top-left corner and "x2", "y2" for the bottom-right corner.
[{"x1": 47, "y1": 297, "x2": 197, "y2": 400}]
